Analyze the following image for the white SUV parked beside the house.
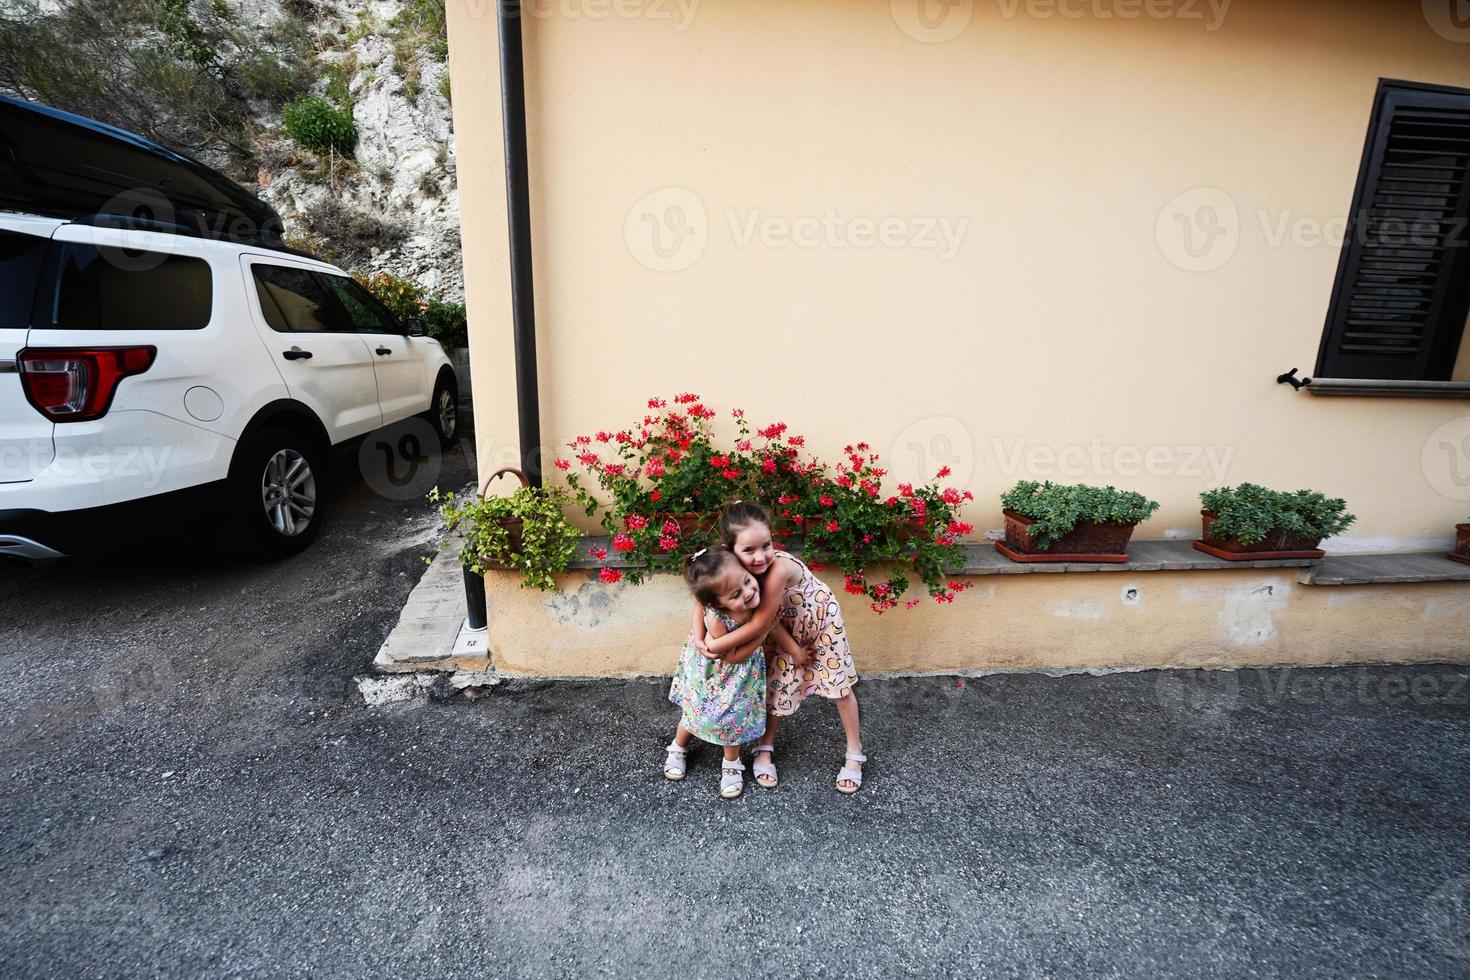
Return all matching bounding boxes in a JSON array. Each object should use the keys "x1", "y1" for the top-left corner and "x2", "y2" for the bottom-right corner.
[{"x1": 0, "y1": 212, "x2": 457, "y2": 560}]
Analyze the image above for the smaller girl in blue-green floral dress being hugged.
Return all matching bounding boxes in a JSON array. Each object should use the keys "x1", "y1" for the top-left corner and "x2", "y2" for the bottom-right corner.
[{"x1": 663, "y1": 545, "x2": 801, "y2": 799}]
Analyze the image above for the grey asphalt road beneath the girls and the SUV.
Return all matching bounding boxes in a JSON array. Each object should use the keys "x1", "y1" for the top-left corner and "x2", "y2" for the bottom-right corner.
[{"x1": 0, "y1": 431, "x2": 1470, "y2": 977}]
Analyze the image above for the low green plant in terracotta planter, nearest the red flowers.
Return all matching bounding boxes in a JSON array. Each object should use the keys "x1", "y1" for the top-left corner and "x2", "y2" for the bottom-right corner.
[{"x1": 995, "y1": 480, "x2": 1158, "y2": 563}]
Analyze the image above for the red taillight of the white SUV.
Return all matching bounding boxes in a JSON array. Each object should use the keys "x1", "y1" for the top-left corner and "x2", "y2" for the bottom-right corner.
[{"x1": 15, "y1": 345, "x2": 159, "y2": 422}]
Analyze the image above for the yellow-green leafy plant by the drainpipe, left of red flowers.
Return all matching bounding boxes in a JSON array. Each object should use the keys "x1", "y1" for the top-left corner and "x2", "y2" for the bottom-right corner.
[{"x1": 429, "y1": 486, "x2": 582, "y2": 592}]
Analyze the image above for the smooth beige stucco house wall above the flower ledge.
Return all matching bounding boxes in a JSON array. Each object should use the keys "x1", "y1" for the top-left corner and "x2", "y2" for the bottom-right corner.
[{"x1": 448, "y1": 0, "x2": 1470, "y2": 552}]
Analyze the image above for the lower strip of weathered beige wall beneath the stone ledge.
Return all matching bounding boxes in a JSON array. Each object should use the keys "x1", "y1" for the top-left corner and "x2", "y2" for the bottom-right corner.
[{"x1": 487, "y1": 569, "x2": 1470, "y2": 676}]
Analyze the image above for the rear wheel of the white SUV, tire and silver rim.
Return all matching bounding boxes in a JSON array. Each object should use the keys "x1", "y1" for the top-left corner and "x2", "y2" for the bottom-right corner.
[{"x1": 229, "y1": 426, "x2": 326, "y2": 560}]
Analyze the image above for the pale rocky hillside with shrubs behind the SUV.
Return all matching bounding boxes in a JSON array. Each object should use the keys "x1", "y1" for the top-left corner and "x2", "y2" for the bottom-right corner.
[{"x1": 0, "y1": 0, "x2": 463, "y2": 300}]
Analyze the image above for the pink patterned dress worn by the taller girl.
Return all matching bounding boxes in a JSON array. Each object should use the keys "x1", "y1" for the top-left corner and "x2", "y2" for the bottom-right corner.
[{"x1": 766, "y1": 551, "x2": 857, "y2": 716}]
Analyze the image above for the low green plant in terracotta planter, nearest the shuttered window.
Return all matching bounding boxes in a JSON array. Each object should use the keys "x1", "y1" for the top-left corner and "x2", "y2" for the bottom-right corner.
[{"x1": 1194, "y1": 483, "x2": 1357, "y2": 561}]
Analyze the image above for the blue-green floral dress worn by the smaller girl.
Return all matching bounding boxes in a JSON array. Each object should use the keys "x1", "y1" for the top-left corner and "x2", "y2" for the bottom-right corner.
[{"x1": 669, "y1": 610, "x2": 766, "y2": 745}]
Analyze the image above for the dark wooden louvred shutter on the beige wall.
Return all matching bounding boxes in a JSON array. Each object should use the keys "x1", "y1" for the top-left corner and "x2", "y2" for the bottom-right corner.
[{"x1": 1317, "y1": 81, "x2": 1470, "y2": 381}]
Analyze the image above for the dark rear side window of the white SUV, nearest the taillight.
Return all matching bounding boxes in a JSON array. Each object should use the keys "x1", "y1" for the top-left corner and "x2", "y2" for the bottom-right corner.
[{"x1": 37, "y1": 242, "x2": 213, "y2": 331}]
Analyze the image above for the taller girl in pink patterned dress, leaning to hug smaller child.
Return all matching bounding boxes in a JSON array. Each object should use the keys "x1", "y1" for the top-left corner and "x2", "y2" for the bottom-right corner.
[{"x1": 694, "y1": 501, "x2": 867, "y2": 793}]
